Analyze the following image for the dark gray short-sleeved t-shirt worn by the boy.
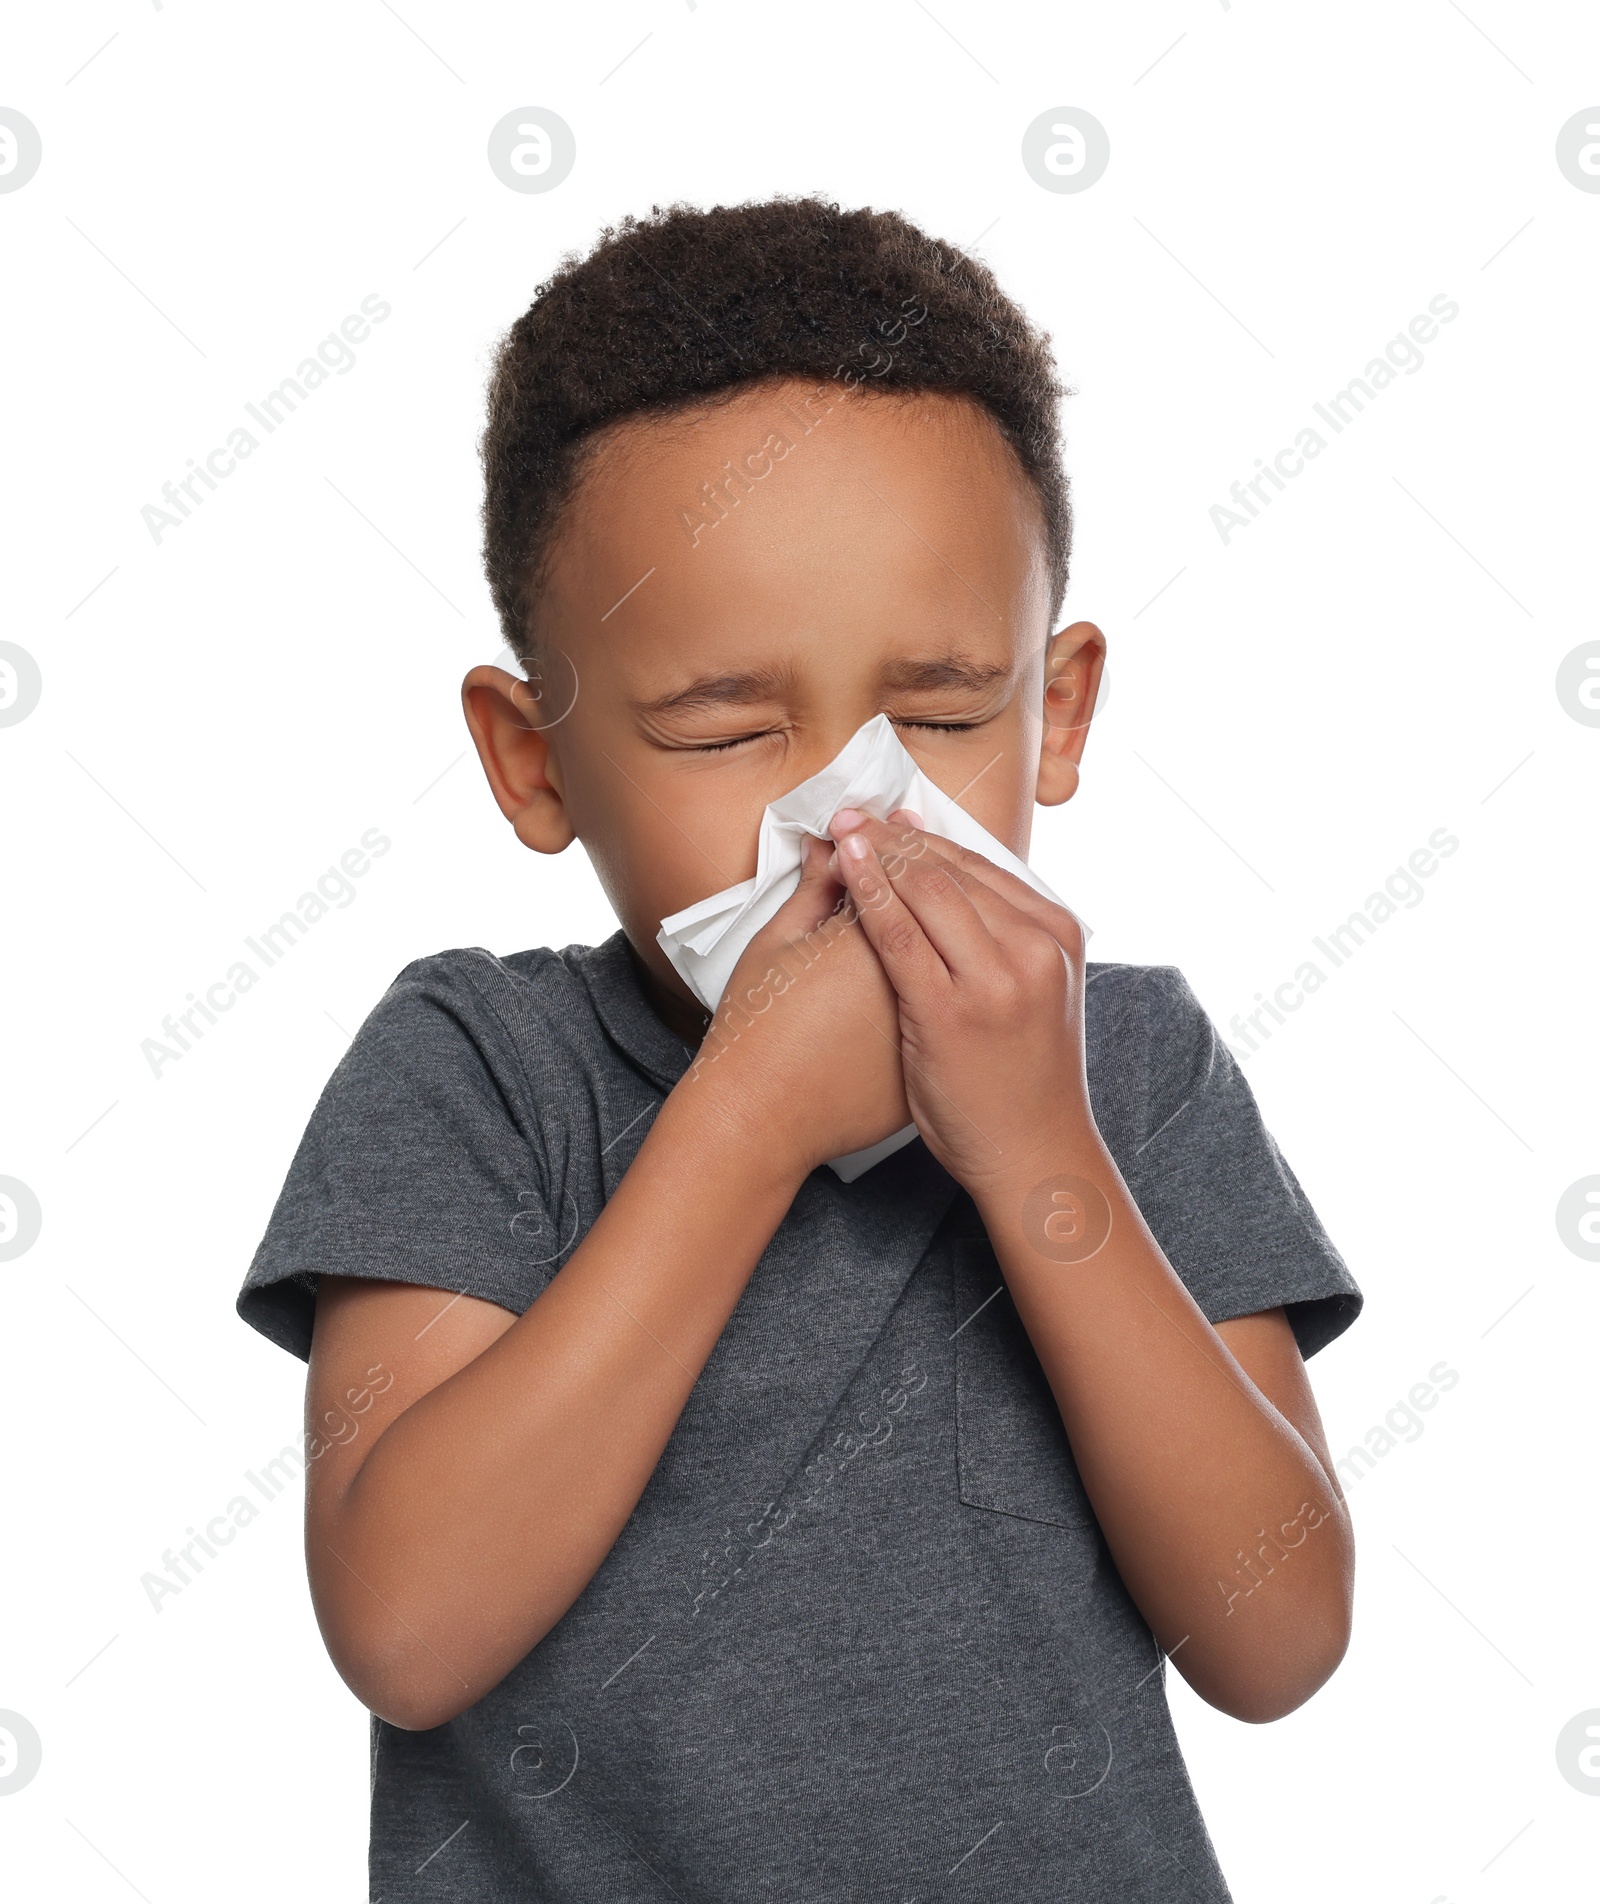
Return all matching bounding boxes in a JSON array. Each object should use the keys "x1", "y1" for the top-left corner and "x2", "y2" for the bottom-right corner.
[{"x1": 238, "y1": 933, "x2": 1362, "y2": 1904}]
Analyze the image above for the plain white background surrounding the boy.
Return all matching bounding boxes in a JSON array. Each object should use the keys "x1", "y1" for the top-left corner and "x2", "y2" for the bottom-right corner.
[{"x1": 0, "y1": 0, "x2": 1600, "y2": 1904}]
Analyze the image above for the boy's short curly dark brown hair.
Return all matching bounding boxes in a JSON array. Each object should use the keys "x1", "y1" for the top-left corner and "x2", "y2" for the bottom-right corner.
[{"x1": 480, "y1": 196, "x2": 1072, "y2": 661}]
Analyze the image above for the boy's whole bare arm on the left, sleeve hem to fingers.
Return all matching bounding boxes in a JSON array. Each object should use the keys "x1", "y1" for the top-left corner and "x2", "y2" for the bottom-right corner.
[{"x1": 307, "y1": 843, "x2": 907, "y2": 1729}]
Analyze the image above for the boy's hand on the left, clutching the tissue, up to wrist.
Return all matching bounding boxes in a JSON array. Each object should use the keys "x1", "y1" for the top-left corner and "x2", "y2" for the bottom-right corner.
[{"x1": 674, "y1": 840, "x2": 910, "y2": 1180}]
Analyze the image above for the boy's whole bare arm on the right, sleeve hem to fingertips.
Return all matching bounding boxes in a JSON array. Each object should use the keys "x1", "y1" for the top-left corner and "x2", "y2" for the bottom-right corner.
[{"x1": 836, "y1": 815, "x2": 1354, "y2": 1721}]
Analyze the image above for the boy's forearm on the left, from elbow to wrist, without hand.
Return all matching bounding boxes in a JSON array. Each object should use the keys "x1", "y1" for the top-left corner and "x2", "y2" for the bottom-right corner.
[{"x1": 309, "y1": 1091, "x2": 798, "y2": 1725}]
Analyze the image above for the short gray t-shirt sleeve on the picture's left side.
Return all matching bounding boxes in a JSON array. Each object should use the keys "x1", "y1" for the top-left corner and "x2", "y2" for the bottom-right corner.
[{"x1": 238, "y1": 960, "x2": 562, "y2": 1358}]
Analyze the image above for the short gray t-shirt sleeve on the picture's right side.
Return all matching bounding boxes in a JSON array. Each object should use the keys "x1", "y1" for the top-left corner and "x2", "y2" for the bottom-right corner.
[{"x1": 1124, "y1": 965, "x2": 1362, "y2": 1356}]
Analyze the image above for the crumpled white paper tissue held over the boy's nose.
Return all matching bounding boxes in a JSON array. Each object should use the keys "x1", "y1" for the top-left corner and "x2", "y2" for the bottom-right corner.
[{"x1": 655, "y1": 714, "x2": 1088, "y2": 1182}]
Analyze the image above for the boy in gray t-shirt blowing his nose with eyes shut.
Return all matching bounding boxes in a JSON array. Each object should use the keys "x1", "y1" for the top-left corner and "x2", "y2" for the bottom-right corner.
[{"x1": 240, "y1": 200, "x2": 1360, "y2": 1904}]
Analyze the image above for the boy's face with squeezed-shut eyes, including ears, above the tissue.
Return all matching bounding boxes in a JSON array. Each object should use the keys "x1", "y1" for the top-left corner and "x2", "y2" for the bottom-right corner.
[{"x1": 463, "y1": 379, "x2": 1105, "y2": 1021}]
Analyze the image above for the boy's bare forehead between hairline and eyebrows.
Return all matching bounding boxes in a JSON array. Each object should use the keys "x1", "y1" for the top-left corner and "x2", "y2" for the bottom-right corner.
[{"x1": 541, "y1": 379, "x2": 1048, "y2": 689}]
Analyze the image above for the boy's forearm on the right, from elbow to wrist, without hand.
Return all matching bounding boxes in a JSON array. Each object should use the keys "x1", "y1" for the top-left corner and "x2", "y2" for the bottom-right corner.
[{"x1": 977, "y1": 1118, "x2": 1352, "y2": 1719}]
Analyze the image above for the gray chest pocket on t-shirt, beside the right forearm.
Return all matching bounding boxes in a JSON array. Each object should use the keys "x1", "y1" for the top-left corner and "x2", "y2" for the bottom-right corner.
[{"x1": 950, "y1": 1238, "x2": 1099, "y2": 1537}]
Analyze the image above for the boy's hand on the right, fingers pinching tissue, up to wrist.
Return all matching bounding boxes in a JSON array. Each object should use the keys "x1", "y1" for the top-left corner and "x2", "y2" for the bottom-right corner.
[{"x1": 832, "y1": 809, "x2": 1101, "y2": 1196}]
